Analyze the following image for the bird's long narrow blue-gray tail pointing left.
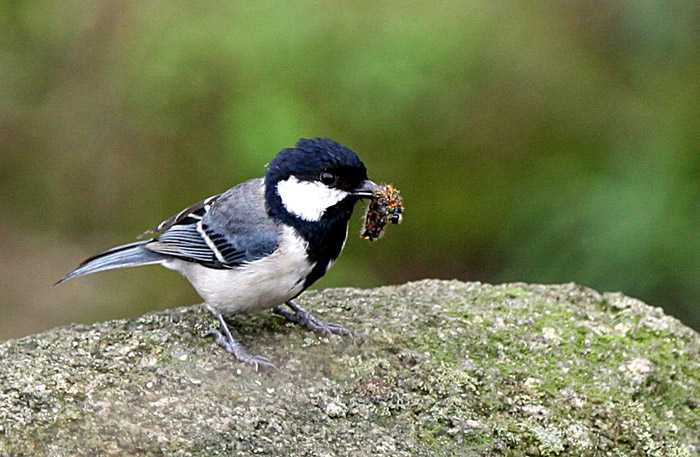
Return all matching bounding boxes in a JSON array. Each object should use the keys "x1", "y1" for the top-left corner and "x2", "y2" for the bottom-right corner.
[{"x1": 54, "y1": 240, "x2": 167, "y2": 286}]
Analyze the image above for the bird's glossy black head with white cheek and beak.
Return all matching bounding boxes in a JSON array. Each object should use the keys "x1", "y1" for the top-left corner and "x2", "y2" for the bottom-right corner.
[{"x1": 265, "y1": 138, "x2": 378, "y2": 222}]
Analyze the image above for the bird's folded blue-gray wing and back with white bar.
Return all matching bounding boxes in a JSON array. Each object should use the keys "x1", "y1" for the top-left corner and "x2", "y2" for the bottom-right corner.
[{"x1": 145, "y1": 179, "x2": 279, "y2": 268}]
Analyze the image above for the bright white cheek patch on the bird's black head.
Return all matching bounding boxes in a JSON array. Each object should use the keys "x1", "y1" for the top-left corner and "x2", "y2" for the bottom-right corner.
[{"x1": 277, "y1": 176, "x2": 350, "y2": 222}]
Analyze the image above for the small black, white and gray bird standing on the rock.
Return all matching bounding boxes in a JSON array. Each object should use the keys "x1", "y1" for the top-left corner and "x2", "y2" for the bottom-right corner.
[{"x1": 56, "y1": 138, "x2": 379, "y2": 371}]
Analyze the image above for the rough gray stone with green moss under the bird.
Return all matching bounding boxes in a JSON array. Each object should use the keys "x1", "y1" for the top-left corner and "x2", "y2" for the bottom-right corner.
[{"x1": 0, "y1": 280, "x2": 700, "y2": 457}]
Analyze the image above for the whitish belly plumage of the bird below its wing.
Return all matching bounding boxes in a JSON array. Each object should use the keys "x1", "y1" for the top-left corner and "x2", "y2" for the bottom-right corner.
[{"x1": 164, "y1": 227, "x2": 314, "y2": 314}]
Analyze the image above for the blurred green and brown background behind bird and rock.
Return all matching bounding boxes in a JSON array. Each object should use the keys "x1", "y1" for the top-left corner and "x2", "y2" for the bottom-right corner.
[{"x1": 0, "y1": 0, "x2": 700, "y2": 339}]
